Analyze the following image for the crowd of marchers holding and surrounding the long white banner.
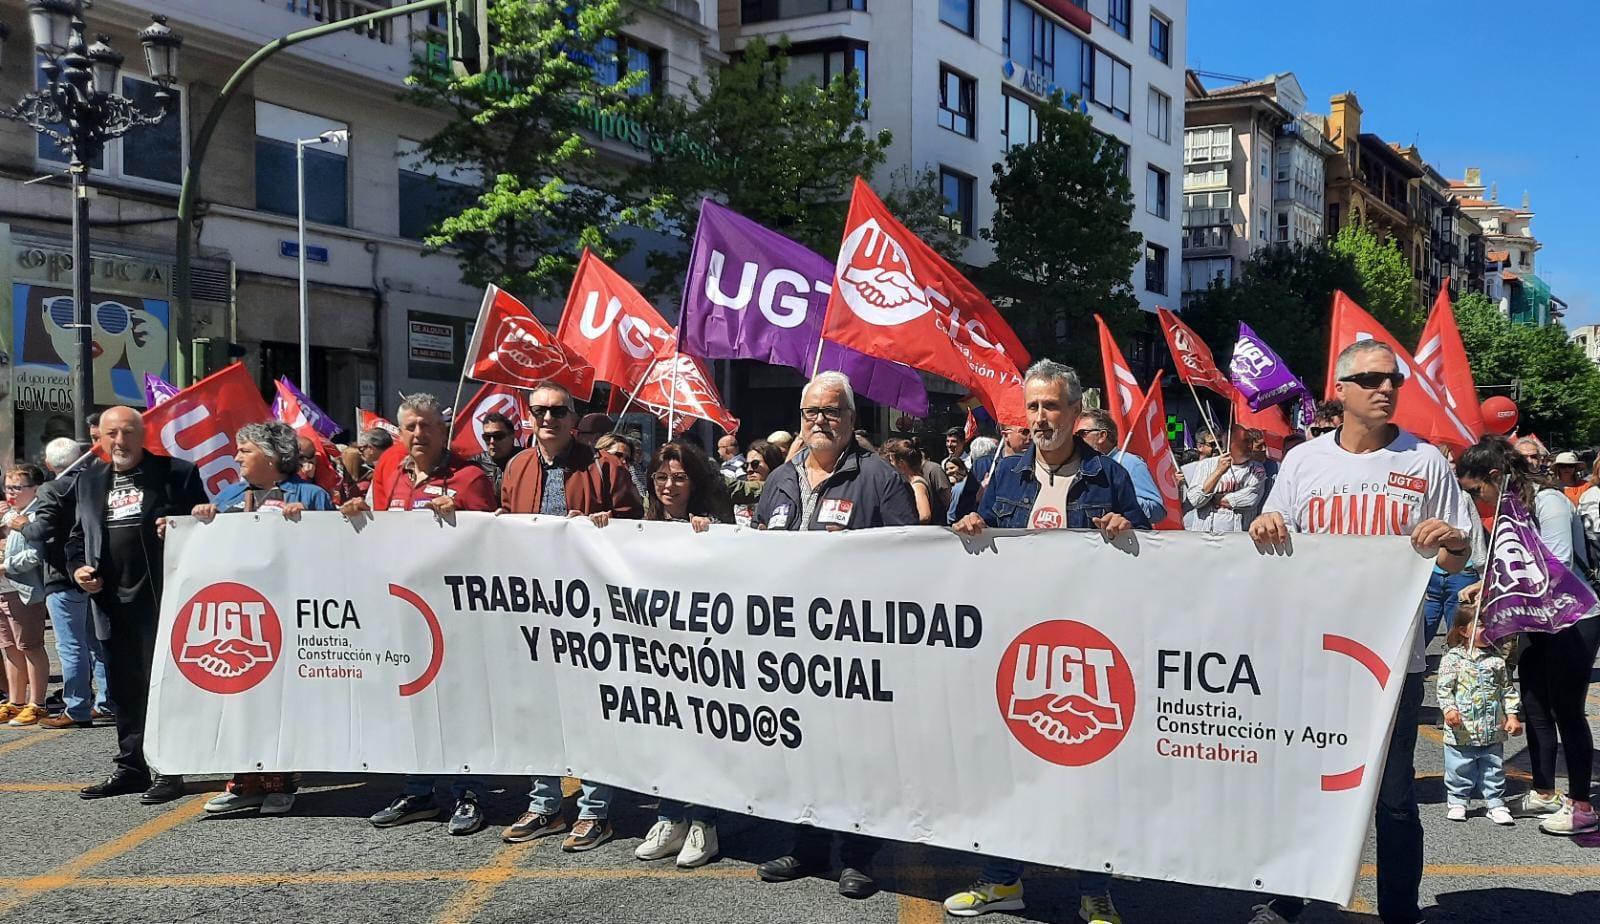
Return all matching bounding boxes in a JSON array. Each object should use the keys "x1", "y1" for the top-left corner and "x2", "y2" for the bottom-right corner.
[{"x1": 0, "y1": 341, "x2": 1600, "y2": 924}]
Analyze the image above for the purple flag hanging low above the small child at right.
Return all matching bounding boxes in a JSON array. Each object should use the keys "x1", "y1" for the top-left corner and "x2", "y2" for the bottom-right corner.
[{"x1": 1478, "y1": 491, "x2": 1597, "y2": 644}]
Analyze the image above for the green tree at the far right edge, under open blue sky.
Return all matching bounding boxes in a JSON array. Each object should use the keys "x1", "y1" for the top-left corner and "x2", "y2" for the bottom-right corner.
[{"x1": 1454, "y1": 293, "x2": 1600, "y2": 448}]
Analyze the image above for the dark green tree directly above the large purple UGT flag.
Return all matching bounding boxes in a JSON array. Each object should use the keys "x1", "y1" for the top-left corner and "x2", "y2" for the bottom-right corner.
[{"x1": 635, "y1": 37, "x2": 889, "y2": 288}]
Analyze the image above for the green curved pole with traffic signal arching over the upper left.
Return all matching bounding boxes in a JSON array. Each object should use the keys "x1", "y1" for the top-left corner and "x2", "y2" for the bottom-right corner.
[{"x1": 170, "y1": 0, "x2": 488, "y2": 380}]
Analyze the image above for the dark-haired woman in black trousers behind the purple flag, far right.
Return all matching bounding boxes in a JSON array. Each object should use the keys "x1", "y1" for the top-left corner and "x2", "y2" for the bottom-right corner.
[{"x1": 1456, "y1": 436, "x2": 1600, "y2": 834}]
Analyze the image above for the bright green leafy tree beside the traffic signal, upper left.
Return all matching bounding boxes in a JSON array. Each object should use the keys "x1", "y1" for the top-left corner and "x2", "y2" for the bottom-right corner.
[{"x1": 405, "y1": 0, "x2": 646, "y2": 296}]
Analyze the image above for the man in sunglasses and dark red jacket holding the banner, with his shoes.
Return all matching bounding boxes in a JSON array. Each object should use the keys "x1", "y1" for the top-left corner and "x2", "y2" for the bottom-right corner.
[{"x1": 501, "y1": 382, "x2": 645, "y2": 854}]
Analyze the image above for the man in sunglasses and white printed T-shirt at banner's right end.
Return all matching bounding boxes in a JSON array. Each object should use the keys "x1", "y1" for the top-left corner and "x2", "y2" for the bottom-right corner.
[{"x1": 1250, "y1": 341, "x2": 1474, "y2": 924}]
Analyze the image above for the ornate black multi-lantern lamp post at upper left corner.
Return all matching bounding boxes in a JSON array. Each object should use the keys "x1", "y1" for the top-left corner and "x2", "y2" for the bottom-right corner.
[{"x1": 0, "y1": 0, "x2": 182, "y2": 443}]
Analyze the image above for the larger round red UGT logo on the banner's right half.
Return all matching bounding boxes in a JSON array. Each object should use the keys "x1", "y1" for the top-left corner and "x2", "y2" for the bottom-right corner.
[{"x1": 995, "y1": 619, "x2": 1134, "y2": 767}]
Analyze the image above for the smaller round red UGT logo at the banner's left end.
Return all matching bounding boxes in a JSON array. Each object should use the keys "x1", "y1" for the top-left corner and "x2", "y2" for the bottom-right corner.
[{"x1": 173, "y1": 582, "x2": 283, "y2": 694}]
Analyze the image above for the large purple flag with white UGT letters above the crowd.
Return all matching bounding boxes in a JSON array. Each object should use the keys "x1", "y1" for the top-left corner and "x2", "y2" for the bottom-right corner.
[{"x1": 678, "y1": 200, "x2": 928, "y2": 417}]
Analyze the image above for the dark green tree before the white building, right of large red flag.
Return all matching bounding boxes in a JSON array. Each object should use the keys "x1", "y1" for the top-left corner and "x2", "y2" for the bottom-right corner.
[{"x1": 974, "y1": 93, "x2": 1142, "y2": 380}]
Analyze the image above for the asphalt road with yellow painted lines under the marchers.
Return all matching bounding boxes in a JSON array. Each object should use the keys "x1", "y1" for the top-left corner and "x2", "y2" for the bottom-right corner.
[{"x1": 0, "y1": 633, "x2": 1600, "y2": 924}]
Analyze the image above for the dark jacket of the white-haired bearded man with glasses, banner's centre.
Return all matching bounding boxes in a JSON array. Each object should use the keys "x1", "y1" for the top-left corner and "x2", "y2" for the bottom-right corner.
[{"x1": 755, "y1": 441, "x2": 918, "y2": 531}]
